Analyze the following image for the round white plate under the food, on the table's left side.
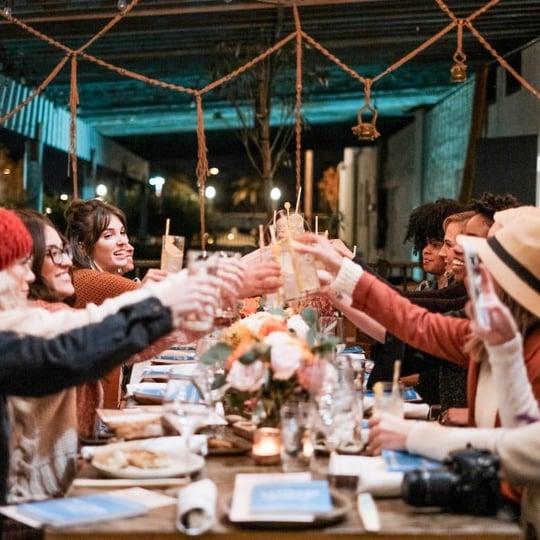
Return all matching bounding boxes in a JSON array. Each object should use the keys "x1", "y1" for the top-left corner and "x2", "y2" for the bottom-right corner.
[{"x1": 92, "y1": 437, "x2": 205, "y2": 479}]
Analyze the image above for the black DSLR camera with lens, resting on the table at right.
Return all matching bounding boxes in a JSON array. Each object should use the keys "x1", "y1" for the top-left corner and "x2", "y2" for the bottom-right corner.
[{"x1": 401, "y1": 446, "x2": 502, "y2": 516}]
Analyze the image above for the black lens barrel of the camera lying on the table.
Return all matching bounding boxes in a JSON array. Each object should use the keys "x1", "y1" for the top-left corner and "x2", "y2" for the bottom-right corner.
[{"x1": 401, "y1": 469, "x2": 459, "y2": 507}]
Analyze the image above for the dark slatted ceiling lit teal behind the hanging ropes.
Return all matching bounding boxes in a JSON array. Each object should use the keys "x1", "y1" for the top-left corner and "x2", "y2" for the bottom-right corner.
[{"x1": 0, "y1": 0, "x2": 540, "y2": 157}]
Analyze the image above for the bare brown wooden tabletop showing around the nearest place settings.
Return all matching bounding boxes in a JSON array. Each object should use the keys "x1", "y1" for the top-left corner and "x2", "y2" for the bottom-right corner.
[{"x1": 45, "y1": 455, "x2": 520, "y2": 540}]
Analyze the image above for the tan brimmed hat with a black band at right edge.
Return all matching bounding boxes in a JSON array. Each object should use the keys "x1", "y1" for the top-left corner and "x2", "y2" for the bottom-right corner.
[{"x1": 457, "y1": 216, "x2": 540, "y2": 317}]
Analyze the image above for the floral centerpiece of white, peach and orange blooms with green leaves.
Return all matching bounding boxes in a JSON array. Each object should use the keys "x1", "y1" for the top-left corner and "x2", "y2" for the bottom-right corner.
[{"x1": 200, "y1": 308, "x2": 335, "y2": 424}]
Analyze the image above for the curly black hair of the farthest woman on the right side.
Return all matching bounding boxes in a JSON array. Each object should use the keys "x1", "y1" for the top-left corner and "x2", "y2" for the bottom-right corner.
[{"x1": 403, "y1": 199, "x2": 470, "y2": 254}]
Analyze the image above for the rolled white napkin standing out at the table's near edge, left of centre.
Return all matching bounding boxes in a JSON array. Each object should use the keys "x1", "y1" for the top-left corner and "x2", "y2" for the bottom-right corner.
[{"x1": 176, "y1": 478, "x2": 217, "y2": 536}]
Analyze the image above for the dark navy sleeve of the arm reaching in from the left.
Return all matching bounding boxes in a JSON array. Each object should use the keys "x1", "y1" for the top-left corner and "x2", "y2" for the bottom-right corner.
[{"x1": 0, "y1": 298, "x2": 172, "y2": 397}]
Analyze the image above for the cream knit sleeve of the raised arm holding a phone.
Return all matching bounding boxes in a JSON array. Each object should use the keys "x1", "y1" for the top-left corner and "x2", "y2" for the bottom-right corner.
[{"x1": 486, "y1": 334, "x2": 540, "y2": 427}]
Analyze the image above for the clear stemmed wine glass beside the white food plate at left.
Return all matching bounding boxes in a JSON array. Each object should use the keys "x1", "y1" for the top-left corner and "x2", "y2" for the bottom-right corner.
[{"x1": 163, "y1": 369, "x2": 211, "y2": 475}]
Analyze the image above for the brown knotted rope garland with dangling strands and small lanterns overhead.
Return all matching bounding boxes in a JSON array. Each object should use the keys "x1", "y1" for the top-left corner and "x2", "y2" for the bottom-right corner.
[{"x1": 0, "y1": 0, "x2": 540, "y2": 217}]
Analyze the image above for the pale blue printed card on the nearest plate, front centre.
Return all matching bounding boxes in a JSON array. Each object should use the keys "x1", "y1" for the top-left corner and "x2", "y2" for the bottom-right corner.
[{"x1": 251, "y1": 480, "x2": 332, "y2": 514}]
